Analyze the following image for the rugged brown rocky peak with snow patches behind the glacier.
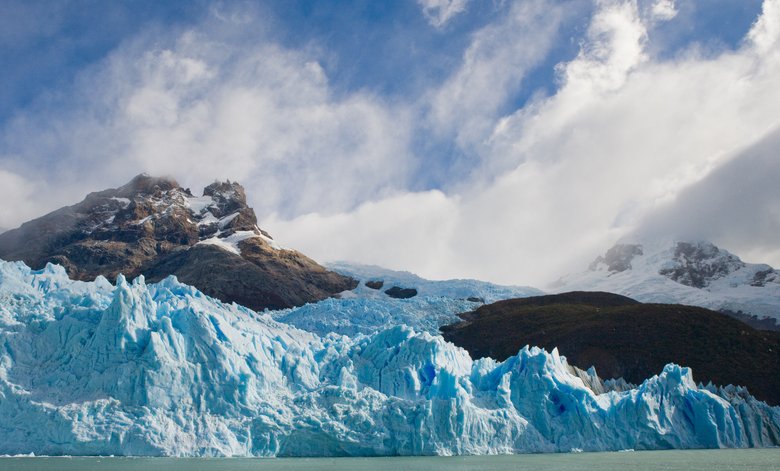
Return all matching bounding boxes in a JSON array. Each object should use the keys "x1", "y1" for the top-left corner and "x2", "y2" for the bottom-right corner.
[{"x1": 0, "y1": 174, "x2": 357, "y2": 310}]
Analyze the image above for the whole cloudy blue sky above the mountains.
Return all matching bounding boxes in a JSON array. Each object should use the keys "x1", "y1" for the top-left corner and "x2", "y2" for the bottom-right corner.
[{"x1": 0, "y1": 0, "x2": 780, "y2": 287}]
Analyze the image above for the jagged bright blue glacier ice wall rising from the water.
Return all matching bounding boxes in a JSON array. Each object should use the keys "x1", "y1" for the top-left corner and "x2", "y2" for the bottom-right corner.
[{"x1": 0, "y1": 262, "x2": 780, "y2": 456}]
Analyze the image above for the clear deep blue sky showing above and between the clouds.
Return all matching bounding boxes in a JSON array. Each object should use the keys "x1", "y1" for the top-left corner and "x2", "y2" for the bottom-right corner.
[{"x1": 0, "y1": 0, "x2": 761, "y2": 119}]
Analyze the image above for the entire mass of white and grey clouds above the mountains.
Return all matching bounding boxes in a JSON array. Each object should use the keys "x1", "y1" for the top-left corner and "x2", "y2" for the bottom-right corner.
[{"x1": 0, "y1": 0, "x2": 780, "y2": 285}]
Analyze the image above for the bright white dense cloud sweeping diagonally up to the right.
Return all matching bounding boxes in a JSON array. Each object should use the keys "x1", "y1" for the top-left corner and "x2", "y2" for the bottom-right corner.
[{"x1": 270, "y1": 1, "x2": 780, "y2": 284}]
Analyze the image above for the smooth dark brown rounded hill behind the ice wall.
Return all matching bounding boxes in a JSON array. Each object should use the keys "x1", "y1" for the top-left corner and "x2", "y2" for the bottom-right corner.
[{"x1": 442, "y1": 292, "x2": 780, "y2": 404}]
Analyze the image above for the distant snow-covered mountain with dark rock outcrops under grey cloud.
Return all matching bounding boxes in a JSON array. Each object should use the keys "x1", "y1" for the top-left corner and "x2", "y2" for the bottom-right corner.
[{"x1": 553, "y1": 241, "x2": 780, "y2": 327}]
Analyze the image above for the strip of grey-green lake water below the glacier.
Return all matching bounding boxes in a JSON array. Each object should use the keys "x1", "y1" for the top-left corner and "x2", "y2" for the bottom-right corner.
[{"x1": 0, "y1": 448, "x2": 780, "y2": 471}]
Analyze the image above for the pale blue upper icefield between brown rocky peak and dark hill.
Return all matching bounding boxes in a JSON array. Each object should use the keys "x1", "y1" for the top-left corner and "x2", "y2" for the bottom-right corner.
[{"x1": 269, "y1": 262, "x2": 542, "y2": 336}]
